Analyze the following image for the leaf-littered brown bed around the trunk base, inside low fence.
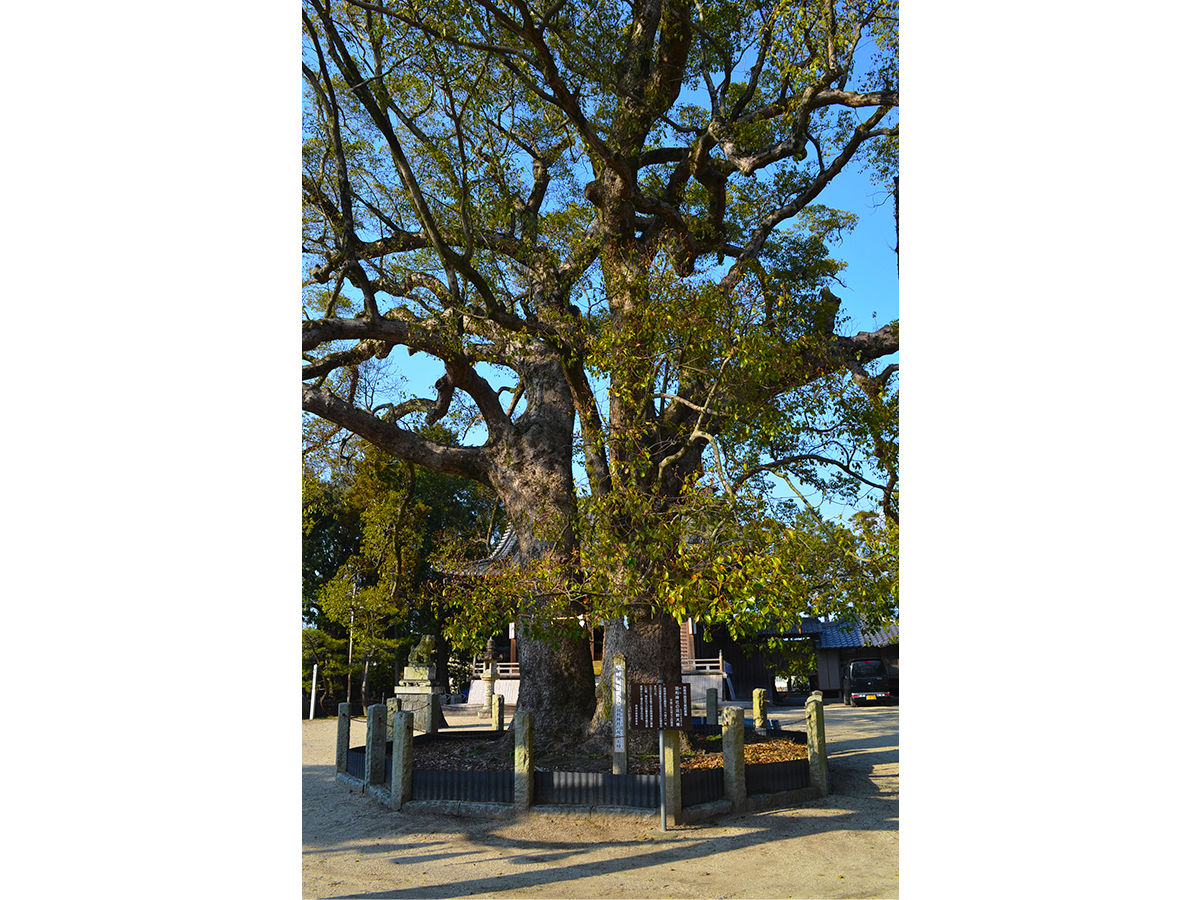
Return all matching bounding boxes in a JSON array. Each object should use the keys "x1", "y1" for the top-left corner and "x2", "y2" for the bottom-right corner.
[{"x1": 413, "y1": 728, "x2": 809, "y2": 775}]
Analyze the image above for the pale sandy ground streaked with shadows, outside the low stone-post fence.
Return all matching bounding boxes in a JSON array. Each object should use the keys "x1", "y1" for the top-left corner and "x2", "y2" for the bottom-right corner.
[{"x1": 301, "y1": 703, "x2": 900, "y2": 898}]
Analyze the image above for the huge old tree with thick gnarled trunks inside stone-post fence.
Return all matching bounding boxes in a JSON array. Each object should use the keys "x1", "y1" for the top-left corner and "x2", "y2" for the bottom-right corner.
[{"x1": 302, "y1": 0, "x2": 899, "y2": 737}]
